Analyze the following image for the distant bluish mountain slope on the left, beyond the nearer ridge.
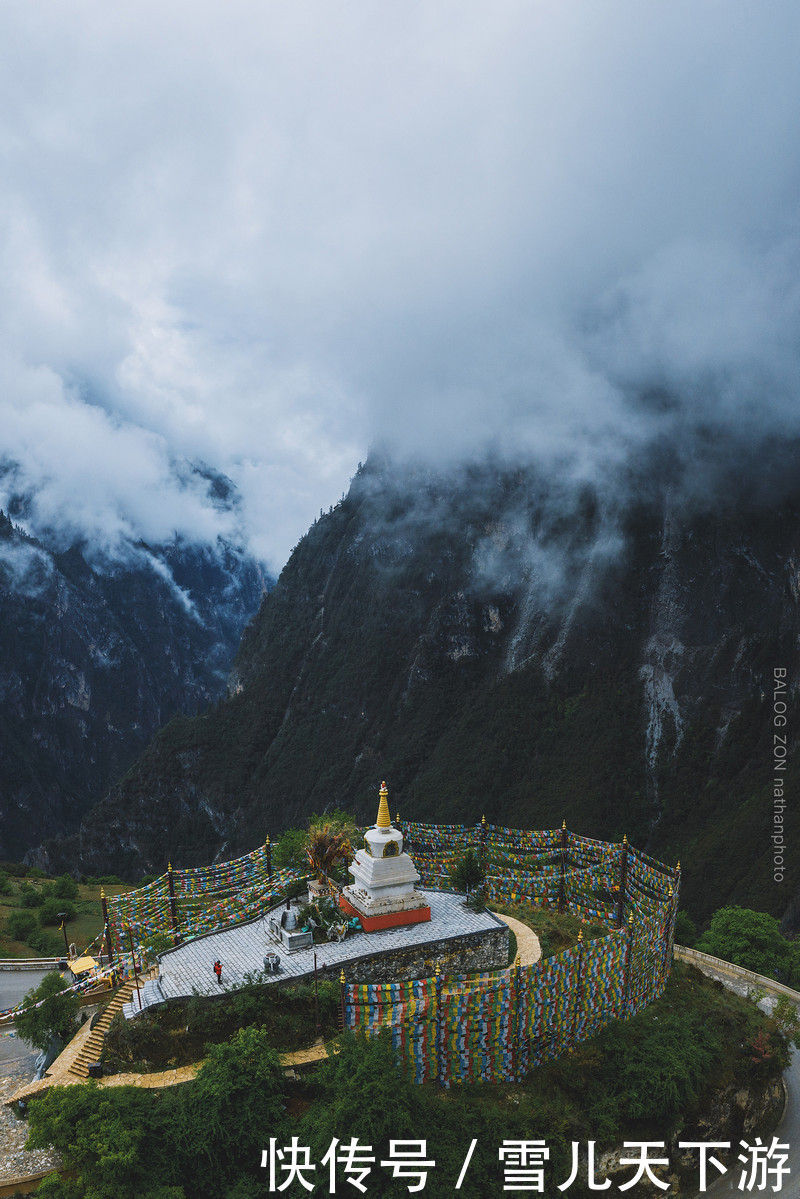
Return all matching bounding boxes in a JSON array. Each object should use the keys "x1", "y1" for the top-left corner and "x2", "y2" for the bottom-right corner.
[{"x1": 0, "y1": 514, "x2": 268, "y2": 860}]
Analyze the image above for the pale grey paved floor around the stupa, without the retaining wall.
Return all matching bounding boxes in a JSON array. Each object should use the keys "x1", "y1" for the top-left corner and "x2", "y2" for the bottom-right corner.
[{"x1": 125, "y1": 891, "x2": 506, "y2": 1017}]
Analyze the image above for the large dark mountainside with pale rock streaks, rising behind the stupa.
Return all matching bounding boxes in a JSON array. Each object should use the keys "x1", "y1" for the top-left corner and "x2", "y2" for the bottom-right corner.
[{"x1": 54, "y1": 460, "x2": 800, "y2": 917}]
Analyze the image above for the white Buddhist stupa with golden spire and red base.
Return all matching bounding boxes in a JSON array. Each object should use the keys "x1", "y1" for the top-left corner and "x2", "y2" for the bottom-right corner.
[{"x1": 339, "y1": 783, "x2": 431, "y2": 933}]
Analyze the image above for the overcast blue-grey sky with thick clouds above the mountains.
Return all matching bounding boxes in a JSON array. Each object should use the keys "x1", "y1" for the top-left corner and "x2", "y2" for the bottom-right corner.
[{"x1": 0, "y1": 0, "x2": 800, "y2": 568}]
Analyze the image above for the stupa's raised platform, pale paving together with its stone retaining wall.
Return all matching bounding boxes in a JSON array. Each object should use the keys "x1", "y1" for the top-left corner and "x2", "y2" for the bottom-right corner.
[{"x1": 126, "y1": 891, "x2": 509, "y2": 1016}]
